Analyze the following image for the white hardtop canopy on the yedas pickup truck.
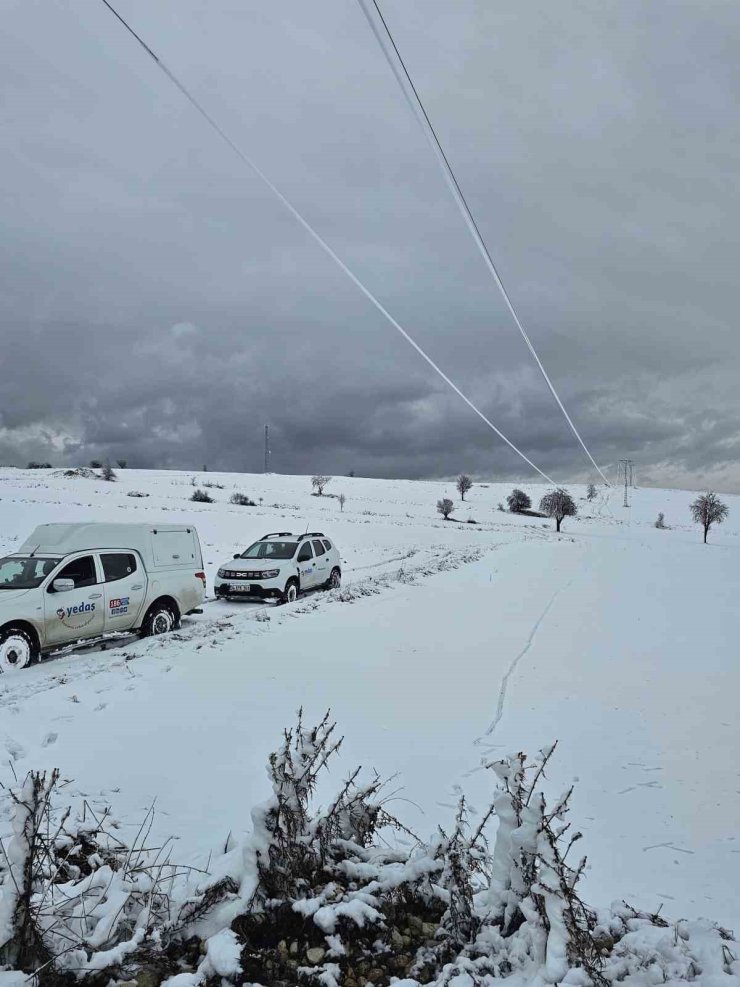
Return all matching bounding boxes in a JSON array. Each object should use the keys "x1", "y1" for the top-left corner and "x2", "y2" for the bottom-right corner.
[{"x1": 14, "y1": 522, "x2": 203, "y2": 569}]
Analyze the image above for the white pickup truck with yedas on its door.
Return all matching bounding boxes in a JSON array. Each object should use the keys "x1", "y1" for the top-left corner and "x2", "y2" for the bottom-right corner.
[{"x1": 0, "y1": 523, "x2": 206, "y2": 671}]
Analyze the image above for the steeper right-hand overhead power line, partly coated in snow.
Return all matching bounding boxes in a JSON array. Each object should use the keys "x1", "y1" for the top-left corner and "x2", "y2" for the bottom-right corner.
[{"x1": 358, "y1": 0, "x2": 609, "y2": 486}]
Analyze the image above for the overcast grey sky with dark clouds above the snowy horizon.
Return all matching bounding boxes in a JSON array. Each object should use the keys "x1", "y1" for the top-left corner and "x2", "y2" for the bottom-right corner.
[{"x1": 0, "y1": 0, "x2": 740, "y2": 491}]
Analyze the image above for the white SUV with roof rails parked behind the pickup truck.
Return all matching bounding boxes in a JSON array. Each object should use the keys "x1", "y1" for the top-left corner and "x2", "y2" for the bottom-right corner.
[{"x1": 214, "y1": 531, "x2": 342, "y2": 603}]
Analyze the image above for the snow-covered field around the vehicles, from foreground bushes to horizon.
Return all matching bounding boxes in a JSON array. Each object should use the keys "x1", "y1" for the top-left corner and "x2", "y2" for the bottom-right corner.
[{"x1": 0, "y1": 469, "x2": 740, "y2": 931}]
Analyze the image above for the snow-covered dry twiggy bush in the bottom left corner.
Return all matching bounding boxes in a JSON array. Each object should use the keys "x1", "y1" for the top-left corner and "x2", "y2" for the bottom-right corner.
[{"x1": 0, "y1": 771, "x2": 236, "y2": 985}]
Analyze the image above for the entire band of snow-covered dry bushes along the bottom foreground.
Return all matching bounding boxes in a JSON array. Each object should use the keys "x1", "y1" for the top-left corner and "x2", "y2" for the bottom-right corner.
[{"x1": 0, "y1": 713, "x2": 740, "y2": 987}]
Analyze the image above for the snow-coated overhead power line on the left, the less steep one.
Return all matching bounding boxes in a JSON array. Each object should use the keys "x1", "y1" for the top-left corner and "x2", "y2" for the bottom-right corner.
[{"x1": 92, "y1": 0, "x2": 555, "y2": 483}]
